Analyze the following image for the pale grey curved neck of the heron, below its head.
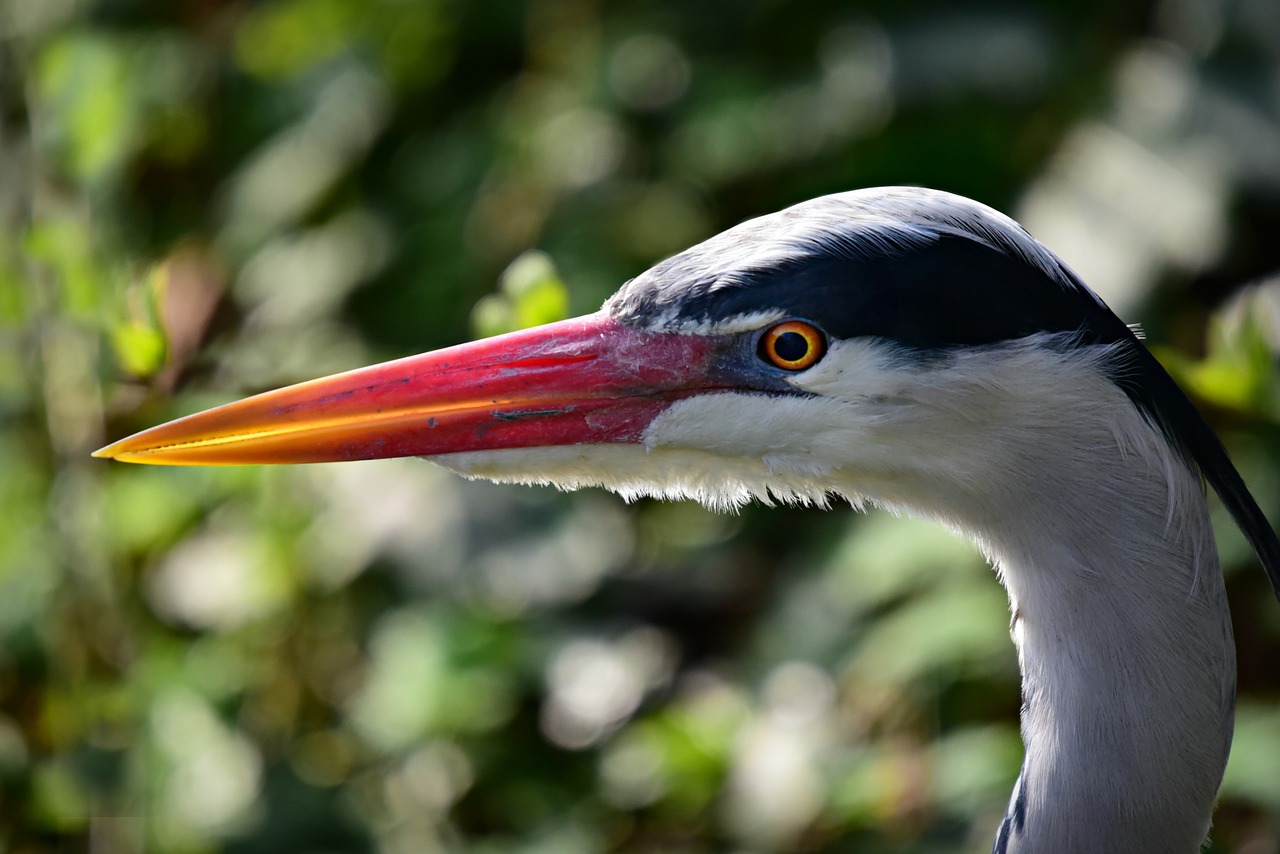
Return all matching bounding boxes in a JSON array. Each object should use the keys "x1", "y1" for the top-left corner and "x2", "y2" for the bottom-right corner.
[{"x1": 982, "y1": 443, "x2": 1235, "y2": 854}]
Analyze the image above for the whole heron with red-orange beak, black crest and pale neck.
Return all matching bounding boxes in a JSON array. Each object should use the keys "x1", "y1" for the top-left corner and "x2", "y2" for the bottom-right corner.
[{"x1": 95, "y1": 187, "x2": 1280, "y2": 854}]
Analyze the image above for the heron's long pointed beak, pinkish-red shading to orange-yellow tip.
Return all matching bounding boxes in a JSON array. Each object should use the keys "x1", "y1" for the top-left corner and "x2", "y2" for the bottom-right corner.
[{"x1": 93, "y1": 314, "x2": 717, "y2": 466}]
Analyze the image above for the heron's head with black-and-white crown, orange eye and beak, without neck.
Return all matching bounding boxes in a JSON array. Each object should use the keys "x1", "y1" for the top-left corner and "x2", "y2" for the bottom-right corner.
[{"x1": 85, "y1": 188, "x2": 1182, "y2": 514}]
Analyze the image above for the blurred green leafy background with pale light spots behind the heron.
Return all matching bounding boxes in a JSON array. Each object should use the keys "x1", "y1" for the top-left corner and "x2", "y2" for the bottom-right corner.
[{"x1": 0, "y1": 0, "x2": 1280, "y2": 854}]
